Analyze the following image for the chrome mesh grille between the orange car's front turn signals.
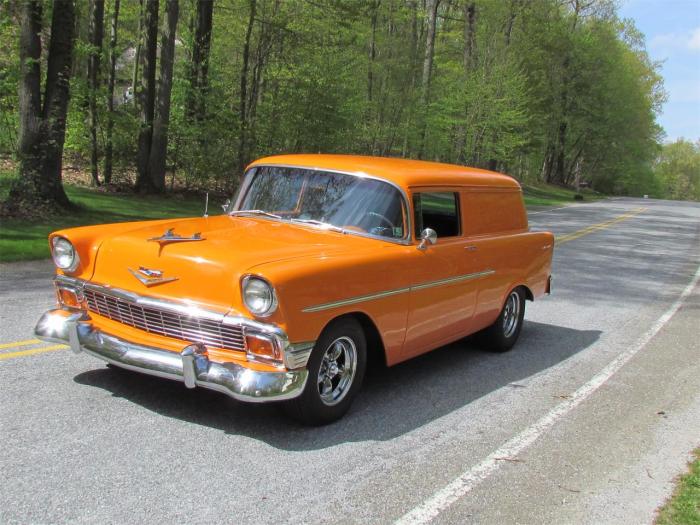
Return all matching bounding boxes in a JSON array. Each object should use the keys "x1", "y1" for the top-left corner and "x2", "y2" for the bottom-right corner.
[{"x1": 83, "y1": 288, "x2": 245, "y2": 350}]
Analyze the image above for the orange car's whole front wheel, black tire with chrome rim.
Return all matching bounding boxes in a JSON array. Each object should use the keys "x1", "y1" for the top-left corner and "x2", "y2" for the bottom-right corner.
[{"x1": 283, "y1": 318, "x2": 367, "y2": 425}]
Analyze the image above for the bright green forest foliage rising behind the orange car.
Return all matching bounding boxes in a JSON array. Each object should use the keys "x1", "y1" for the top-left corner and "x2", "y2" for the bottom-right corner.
[{"x1": 0, "y1": 0, "x2": 680, "y2": 196}]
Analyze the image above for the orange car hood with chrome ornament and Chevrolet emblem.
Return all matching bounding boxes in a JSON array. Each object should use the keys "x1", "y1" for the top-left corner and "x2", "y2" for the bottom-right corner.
[{"x1": 92, "y1": 216, "x2": 366, "y2": 308}]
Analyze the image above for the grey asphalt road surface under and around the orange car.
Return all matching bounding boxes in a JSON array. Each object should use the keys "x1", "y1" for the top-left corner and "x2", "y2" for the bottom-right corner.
[{"x1": 0, "y1": 199, "x2": 700, "y2": 524}]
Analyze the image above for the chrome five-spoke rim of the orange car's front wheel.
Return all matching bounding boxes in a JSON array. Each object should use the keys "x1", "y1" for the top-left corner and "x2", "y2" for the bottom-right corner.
[{"x1": 317, "y1": 337, "x2": 357, "y2": 406}]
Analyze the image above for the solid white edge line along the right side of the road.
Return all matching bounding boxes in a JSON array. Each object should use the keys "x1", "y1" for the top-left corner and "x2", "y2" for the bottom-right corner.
[{"x1": 395, "y1": 266, "x2": 700, "y2": 525}]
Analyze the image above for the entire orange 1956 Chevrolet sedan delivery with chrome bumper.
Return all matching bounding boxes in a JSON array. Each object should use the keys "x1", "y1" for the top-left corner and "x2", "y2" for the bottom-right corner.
[{"x1": 36, "y1": 155, "x2": 554, "y2": 424}]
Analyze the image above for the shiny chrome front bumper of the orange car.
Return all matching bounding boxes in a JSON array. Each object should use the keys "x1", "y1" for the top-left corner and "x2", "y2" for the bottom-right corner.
[{"x1": 34, "y1": 309, "x2": 308, "y2": 402}]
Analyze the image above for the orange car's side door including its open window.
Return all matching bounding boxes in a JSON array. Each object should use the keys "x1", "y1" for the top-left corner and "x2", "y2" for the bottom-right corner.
[{"x1": 404, "y1": 189, "x2": 477, "y2": 357}]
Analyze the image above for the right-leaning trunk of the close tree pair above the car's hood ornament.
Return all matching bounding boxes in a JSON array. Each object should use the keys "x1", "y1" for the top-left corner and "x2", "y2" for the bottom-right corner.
[{"x1": 148, "y1": 0, "x2": 179, "y2": 192}]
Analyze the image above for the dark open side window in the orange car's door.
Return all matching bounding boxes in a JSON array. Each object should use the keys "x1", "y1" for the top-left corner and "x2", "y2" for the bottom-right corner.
[{"x1": 413, "y1": 191, "x2": 460, "y2": 238}]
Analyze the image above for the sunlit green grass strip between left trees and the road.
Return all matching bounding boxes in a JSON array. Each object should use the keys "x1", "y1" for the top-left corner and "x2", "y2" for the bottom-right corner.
[{"x1": 0, "y1": 177, "x2": 208, "y2": 262}]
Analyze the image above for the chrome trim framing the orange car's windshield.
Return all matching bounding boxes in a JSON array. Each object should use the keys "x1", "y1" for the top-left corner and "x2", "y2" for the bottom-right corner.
[{"x1": 232, "y1": 164, "x2": 413, "y2": 245}]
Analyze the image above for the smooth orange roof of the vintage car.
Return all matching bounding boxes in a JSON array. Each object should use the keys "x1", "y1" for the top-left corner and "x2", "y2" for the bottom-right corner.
[{"x1": 249, "y1": 154, "x2": 520, "y2": 190}]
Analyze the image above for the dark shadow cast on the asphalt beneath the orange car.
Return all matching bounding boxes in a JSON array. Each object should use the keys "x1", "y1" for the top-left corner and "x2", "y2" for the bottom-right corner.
[{"x1": 74, "y1": 321, "x2": 601, "y2": 451}]
